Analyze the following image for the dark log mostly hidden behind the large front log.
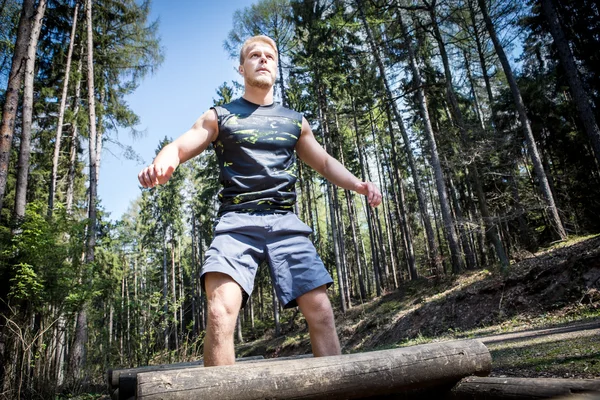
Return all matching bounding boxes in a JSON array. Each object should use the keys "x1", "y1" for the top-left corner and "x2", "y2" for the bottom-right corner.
[{"x1": 108, "y1": 356, "x2": 264, "y2": 400}]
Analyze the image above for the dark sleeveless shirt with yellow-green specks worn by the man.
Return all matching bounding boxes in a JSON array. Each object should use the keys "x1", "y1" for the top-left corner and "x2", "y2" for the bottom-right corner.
[{"x1": 213, "y1": 98, "x2": 302, "y2": 215}]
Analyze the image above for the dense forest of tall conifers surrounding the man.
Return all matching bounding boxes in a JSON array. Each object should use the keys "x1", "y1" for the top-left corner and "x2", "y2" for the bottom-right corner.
[{"x1": 0, "y1": 0, "x2": 600, "y2": 399}]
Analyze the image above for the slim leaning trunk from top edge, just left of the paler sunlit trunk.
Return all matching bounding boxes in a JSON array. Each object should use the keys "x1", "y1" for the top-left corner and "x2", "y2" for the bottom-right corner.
[{"x1": 356, "y1": 1, "x2": 443, "y2": 274}]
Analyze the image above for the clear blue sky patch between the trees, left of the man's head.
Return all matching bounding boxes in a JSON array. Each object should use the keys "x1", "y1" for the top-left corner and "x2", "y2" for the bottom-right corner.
[{"x1": 98, "y1": 0, "x2": 253, "y2": 220}]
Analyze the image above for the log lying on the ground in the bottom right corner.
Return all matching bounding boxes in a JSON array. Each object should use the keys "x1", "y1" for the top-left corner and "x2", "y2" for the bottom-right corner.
[{"x1": 451, "y1": 376, "x2": 600, "y2": 400}]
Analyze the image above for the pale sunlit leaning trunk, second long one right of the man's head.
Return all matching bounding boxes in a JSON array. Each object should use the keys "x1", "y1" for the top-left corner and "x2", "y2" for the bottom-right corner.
[{"x1": 398, "y1": 10, "x2": 463, "y2": 273}]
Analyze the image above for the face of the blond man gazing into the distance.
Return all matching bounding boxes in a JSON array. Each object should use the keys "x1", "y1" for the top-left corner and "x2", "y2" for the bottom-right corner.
[{"x1": 240, "y1": 42, "x2": 277, "y2": 89}]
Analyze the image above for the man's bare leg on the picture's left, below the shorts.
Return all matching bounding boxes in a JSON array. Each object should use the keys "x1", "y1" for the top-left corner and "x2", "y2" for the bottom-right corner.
[{"x1": 204, "y1": 272, "x2": 242, "y2": 367}]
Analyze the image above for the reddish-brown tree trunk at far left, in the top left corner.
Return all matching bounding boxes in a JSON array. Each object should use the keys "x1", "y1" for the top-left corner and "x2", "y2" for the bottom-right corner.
[{"x1": 0, "y1": 0, "x2": 35, "y2": 210}]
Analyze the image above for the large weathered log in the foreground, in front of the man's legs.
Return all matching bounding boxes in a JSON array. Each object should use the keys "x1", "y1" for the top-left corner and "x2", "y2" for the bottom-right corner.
[{"x1": 137, "y1": 340, "x2": 492, "y2": 400}]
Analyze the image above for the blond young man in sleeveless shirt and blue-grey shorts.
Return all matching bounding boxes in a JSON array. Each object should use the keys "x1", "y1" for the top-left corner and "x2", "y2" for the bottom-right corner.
[{"x1": 138, "y1": 36, "x2": 381, "y2": 366}]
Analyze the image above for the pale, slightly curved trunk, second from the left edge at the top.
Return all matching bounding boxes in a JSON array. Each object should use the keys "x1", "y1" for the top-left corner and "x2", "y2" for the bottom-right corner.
[{"x1": 14, "y1": 0, "x2": 48, "y2": 221}]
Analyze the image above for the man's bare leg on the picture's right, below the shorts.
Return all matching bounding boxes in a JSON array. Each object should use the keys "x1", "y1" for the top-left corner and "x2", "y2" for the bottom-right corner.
[{"x1": 296, "y1": 285, "x2": 341, "y2": 357}]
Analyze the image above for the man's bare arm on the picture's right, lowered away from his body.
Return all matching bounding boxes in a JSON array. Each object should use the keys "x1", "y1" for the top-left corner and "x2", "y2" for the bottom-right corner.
[{"x1": 296, "y1": 118, "x2": 381, "y2": 207}]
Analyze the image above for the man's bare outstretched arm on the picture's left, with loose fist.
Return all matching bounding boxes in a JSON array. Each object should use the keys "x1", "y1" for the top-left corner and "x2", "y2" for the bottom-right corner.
[{"x1": 138, "y1": 109, "x2": 219, "y2": 188}]
